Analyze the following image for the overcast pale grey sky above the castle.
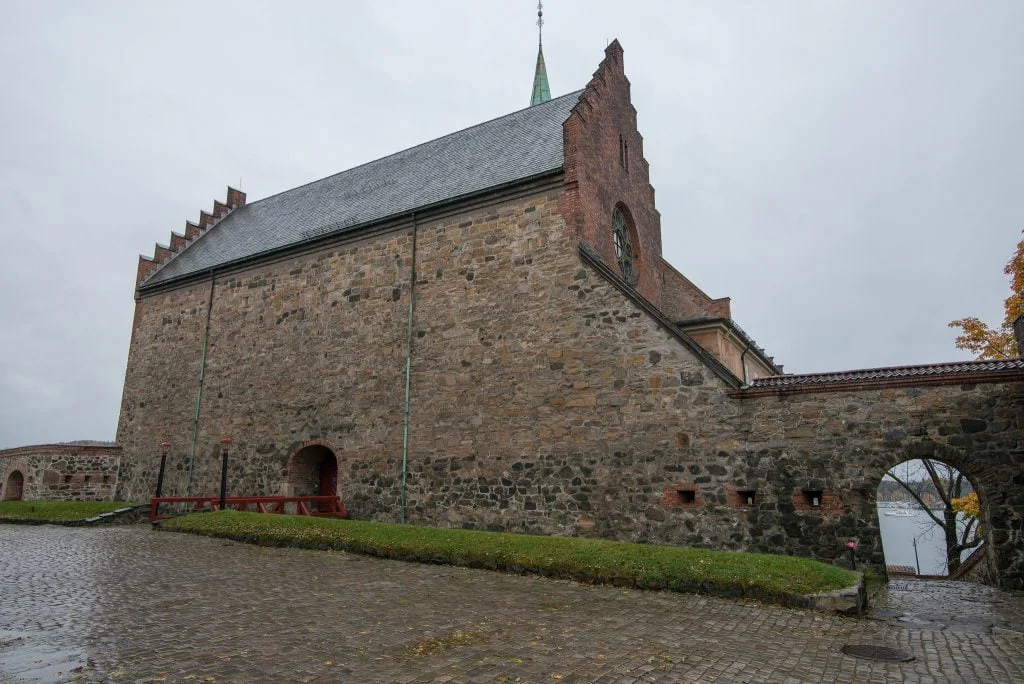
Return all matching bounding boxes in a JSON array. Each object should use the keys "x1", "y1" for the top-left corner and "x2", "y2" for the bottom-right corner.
[{"x1": 0, "y1": 0, "x2": 1024, "y2": 447}]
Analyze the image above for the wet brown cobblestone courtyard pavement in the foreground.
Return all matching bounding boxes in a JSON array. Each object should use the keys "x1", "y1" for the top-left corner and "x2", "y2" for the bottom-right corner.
[{"x1": 0, "y1": 525, "x2": 1024, "y2": 683}]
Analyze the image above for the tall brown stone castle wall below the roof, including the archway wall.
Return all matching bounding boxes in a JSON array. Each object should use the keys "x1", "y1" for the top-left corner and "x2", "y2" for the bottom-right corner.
[{"x1": 119, "y1": 178, "x2": 1024, "y2": 589}]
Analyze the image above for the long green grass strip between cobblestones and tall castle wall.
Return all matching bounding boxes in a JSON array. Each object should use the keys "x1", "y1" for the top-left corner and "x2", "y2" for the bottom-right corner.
[{"x1": 160, "y1": 511, "x2": 858, "y2": 607}]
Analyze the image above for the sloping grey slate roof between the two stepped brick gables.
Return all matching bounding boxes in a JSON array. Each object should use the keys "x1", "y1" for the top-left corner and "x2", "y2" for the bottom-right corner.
[{"x1": 143, "y1": 90, "x2": 583, "y2": 287}]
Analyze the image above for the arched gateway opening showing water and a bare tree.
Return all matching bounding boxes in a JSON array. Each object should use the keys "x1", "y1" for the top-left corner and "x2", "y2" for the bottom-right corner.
[{"x1": 877, "y1": 458, "x2": 986, "y2": 576}]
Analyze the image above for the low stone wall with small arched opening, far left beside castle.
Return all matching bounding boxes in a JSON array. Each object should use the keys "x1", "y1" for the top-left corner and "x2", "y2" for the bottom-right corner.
[{"x1": 0, "y1": 444, "x2": 121, "y2": 501}]
